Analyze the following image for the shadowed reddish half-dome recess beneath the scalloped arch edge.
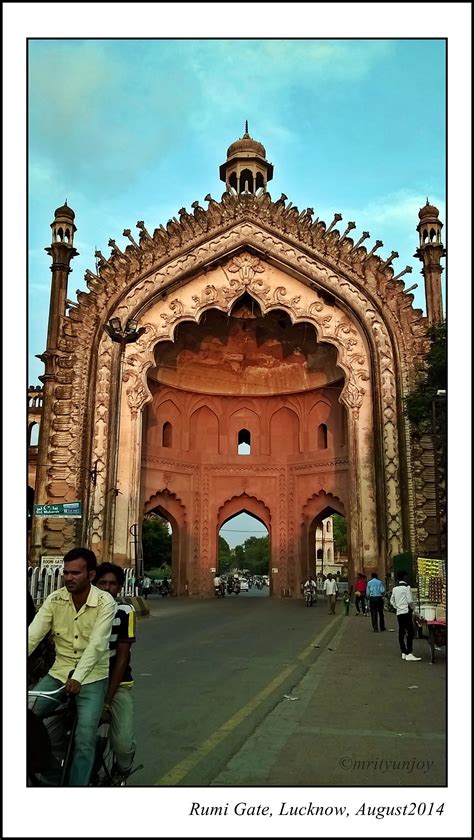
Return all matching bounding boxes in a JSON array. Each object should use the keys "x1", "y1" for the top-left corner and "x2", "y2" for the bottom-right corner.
[{"x1": 148, "y1": 302, "x2": 344, "y2": 396}]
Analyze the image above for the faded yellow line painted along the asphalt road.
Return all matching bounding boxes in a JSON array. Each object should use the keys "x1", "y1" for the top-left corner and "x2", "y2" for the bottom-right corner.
[{"x1": 155, "y1": 616, "x2": 341, "y2": 786}]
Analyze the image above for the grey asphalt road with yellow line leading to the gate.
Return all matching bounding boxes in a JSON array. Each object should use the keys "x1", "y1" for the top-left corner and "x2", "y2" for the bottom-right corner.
[{"x1": 129, "y1": 589, "x2": 336, "y2": 786}]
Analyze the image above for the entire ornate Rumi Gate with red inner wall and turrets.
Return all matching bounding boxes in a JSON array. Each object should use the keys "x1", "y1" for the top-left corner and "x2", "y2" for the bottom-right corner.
[{"x1": 30, "y1": 126, "x2": 444, "y2": 596}]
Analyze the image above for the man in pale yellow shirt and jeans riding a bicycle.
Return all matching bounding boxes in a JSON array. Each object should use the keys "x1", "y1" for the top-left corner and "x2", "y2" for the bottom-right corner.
[{"x1": 28, "y1": 548, "x2": 115, "y2": 786}]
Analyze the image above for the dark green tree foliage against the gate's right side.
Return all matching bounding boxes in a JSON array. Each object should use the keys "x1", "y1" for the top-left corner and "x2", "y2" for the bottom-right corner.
[{"x1": 405, "y1": 321, "x2": 447, "y2": 435}]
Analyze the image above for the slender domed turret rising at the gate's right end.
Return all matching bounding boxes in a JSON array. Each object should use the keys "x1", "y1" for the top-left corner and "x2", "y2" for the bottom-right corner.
[{"x1": 414, "y1": 199, "x2": 446, "y2": 325}]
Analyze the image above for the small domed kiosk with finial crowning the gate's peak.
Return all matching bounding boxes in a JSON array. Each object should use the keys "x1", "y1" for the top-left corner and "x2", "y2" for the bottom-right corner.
[{"x1": 219, "y1": 120, "x2": 273, "y2": 193}]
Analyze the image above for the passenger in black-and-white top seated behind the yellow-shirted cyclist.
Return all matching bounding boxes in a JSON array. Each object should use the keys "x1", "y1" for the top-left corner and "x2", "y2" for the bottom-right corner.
[{"x1": 96, "y1": 563, "x2": 135, "y2": 785}]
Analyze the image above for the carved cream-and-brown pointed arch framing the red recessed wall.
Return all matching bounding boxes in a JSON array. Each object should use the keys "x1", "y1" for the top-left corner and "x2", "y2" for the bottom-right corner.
[{"x1": 35, "y1": 193, "x2": 426, "y2": 588}]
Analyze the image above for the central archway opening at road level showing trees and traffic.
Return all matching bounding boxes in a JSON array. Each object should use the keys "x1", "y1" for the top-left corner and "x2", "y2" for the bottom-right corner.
[{"x1": 217, "y1": 510, "x2": 270, "y2": 598}]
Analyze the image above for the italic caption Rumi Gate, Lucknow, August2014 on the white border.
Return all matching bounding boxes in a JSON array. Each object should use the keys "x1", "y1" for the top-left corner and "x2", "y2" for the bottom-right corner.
[{"x1": 189, "y1": 802, "x2": 444, "y2": 820}]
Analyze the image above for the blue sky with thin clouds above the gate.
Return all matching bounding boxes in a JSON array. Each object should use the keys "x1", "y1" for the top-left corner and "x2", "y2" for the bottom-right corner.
[{"x1": 28, "y1": 38, "x2": 445, "y2": 384}]
